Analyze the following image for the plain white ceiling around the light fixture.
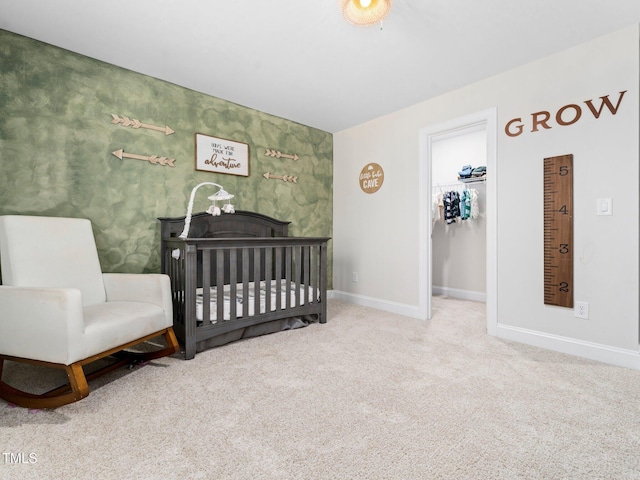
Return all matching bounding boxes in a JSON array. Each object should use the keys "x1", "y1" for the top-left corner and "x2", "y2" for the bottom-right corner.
[{"x1": 0, "y1": 0, "x2": 640, "y2": 133}]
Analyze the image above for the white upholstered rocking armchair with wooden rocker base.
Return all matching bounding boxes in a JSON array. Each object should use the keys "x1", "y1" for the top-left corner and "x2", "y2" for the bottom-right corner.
[{"x1": 0, "y1": 215, "x2": 178, "y2": 408}]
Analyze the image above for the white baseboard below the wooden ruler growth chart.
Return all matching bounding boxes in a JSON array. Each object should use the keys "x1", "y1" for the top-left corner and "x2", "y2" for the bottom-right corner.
[{"x1": 496, "y1": 323, "x2": 640, "y2": 370}]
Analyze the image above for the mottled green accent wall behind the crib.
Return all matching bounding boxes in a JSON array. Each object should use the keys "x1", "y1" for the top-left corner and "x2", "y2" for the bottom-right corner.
[{"x1": 0, "y1": 30, "x2": 333, "y2": 280}]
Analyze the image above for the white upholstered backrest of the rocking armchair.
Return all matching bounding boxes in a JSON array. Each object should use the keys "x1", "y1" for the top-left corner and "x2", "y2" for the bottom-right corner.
[{"x1": 0, "y1": 215, "x2": 106, "y2": 305}]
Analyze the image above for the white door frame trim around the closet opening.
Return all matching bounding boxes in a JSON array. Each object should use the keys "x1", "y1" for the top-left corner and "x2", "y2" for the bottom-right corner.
[{"x1": 418, "y1": 107, "x2": 498, "y2": 335}]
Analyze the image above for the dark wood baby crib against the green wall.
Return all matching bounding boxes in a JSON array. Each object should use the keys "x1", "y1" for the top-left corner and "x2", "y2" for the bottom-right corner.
[{"x1": 159, "y1": 211, "x2": 330, "y2": 360}]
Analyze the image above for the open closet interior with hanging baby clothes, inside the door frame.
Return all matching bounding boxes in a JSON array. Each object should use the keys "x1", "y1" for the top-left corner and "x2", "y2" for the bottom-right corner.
[{"x1": 431, "y1": 124, "x2": 488, "y2": 302}]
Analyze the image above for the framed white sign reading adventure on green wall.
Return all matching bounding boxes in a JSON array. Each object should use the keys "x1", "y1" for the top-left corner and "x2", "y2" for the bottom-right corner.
[{"x1": 195, "y1": 133, "x2": 249, "y2": 177}]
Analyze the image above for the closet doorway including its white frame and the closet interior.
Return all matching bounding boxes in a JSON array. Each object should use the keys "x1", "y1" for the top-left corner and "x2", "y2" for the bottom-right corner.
[{"x1": 420, "y1": 110, "x2": 497, "y2": 333}]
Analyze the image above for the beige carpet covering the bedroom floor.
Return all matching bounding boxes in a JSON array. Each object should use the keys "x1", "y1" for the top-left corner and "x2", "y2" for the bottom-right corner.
[{"x1": 0, "y1": 297, "x2": 640, "y2": 480}]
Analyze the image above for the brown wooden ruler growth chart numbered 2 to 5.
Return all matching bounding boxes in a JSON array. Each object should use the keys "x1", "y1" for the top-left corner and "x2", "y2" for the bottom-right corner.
[{"x1": 544, "y1": 154, "x2": 573, "y2": 308}]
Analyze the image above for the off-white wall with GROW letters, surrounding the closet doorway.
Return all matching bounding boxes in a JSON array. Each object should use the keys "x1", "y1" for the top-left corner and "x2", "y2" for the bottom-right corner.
[{"x1": 333, "y1": 25, "x2": 640, "y2": 368}]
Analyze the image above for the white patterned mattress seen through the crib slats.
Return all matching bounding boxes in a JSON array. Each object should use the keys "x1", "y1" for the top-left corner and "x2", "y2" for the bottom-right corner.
[{"x1": 196, "y1": 280, "x2": 319, "y2": 323}]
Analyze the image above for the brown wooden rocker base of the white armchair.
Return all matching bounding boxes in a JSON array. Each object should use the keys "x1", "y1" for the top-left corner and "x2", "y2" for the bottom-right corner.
[{"x1": 0, "y1": 327, "x2": 179, "y2": 409}]
